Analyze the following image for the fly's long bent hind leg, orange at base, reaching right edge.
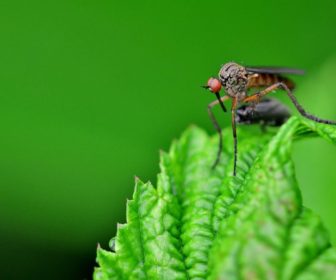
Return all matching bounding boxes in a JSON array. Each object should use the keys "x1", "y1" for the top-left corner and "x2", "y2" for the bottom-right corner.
[{"x1": 243, "y1": 83, "x2": 336, "y2": 124}]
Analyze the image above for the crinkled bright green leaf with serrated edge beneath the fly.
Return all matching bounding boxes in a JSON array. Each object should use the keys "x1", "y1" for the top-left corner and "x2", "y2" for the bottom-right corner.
[{"x1": 94, "y1": 117, "x2": 336, "y2": 279}]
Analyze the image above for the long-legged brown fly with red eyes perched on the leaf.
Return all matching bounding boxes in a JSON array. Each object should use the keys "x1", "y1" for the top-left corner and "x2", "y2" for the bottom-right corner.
[{"x1": 203, "y1": 62, "x2": 336, "y2": 176}]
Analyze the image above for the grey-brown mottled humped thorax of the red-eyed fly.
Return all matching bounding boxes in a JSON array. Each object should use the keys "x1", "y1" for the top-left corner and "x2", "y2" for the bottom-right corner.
[{"x1": 218, "y1": 62, "x2": 248, "y2": 100}]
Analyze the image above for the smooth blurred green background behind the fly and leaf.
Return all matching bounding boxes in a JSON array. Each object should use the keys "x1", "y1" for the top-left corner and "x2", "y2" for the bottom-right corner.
[{"x1": 0, "y1": 0, "x2": 336, "y2": 279}]
